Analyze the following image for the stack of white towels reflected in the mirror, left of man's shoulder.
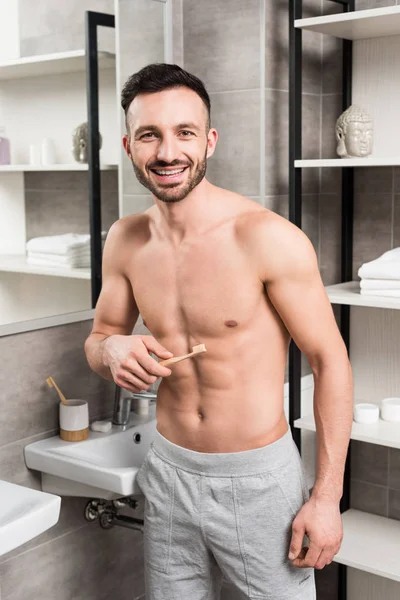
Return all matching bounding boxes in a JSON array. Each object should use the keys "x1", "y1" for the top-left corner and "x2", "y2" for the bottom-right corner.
[{"x1": 26, "y1": 231, "x2": 107, "y2": 269}]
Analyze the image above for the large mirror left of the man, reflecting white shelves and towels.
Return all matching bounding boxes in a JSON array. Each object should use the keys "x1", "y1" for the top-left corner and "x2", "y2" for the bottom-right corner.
[{"x1": 0, "y1": 0, "x2": 165, "y2": 335}]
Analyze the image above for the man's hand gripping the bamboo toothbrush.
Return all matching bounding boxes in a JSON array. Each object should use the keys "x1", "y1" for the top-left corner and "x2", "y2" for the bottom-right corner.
[{"x1": 102, "y1": 335, "x2": 173, "y2": 392}]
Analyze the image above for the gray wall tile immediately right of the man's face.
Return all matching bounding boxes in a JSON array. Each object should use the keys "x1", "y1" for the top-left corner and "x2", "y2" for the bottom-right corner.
[{"x1": 207, "y1": 91, "x2": 260, "y2": 196}]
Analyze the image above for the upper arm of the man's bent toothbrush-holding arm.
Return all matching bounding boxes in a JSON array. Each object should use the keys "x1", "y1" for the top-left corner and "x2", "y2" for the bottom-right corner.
[{"x1": 92, "y1": 223, "x2": 139, "y2": 335}]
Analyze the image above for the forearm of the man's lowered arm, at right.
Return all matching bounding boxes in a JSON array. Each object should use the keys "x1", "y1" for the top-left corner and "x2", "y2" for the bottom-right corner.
[{"x1": 312, "y1": 356, "x2": 353, "y2": 502}]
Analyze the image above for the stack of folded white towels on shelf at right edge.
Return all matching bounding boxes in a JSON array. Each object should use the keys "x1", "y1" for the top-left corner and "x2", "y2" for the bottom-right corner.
[{"x1": 358, "y1": 247, "x2": 400, "y2": 298}]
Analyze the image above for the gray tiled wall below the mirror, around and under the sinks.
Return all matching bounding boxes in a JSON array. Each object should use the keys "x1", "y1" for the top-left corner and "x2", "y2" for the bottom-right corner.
[{"x1": 0, "y1": 321, "x2": 144, "y2": 600}]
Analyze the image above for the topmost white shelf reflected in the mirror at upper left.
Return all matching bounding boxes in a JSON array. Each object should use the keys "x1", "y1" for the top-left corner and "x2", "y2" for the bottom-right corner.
[{"x1": 0, "y1": 50, "x2": 115, "y2": 80}]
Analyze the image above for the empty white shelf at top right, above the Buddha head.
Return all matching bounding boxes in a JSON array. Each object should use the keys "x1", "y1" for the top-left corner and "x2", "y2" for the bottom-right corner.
[{"x1": 294, "y1": 6, "x2": 400, "y2": 40}]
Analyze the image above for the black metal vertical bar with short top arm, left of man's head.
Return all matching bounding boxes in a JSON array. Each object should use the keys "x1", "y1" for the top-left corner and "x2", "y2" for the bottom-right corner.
[{"x1": 85, "y1": 11, "x2": 115, "y2": 308}]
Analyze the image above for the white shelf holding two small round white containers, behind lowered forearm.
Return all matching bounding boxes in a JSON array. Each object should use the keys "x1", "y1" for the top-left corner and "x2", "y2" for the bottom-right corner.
[{"x1": 294, "y1": 415, "x2": 400, "y2": 450}]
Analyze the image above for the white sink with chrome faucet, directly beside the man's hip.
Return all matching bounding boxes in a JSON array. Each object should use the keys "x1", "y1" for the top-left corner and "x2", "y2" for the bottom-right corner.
[{"x1": 24, "y1": 405, "x2": 157, "y2": 500}]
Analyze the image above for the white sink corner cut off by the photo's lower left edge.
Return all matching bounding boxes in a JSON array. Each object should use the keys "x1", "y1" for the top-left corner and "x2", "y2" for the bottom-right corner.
[{"x1": 0, "y1": 481, "x2": 61, "y2": 556}]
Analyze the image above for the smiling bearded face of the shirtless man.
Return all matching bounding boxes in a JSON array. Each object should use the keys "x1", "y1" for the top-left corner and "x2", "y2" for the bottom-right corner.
[{"x1": 123, "y1": 87, "x2": 218, "y2": 202}]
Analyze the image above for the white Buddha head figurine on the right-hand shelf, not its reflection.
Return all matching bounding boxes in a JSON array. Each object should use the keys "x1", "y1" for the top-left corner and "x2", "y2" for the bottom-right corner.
[{"x1": 335, "y1": 104, "x2": 374, "y2": 158}]
